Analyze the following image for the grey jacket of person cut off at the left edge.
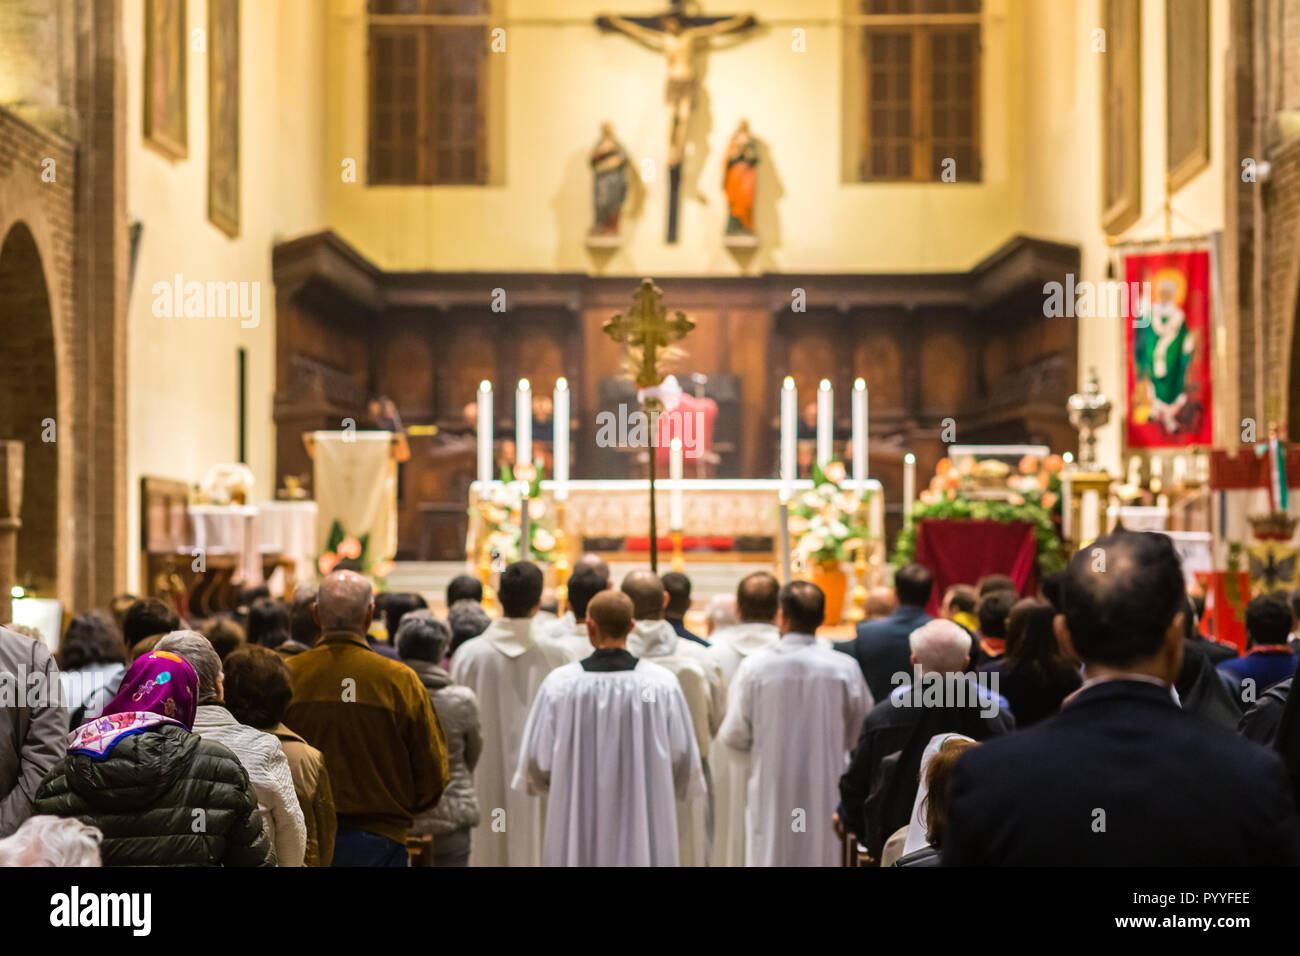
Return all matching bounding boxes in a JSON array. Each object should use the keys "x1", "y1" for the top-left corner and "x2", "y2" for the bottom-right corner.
[{"x1": 0, "y1": 627, "x2": 68, "y2": 838}]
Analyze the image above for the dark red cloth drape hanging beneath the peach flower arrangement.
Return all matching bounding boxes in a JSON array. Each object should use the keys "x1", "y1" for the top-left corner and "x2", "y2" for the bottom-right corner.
[{"x1": 913, "y1": 518, "x2": 1039, "y2": 614}]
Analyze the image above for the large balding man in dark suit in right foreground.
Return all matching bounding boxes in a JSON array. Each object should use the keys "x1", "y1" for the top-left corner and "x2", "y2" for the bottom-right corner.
[{"x1": 941, "y1": 532, "x2": 1300, "y2": 866}]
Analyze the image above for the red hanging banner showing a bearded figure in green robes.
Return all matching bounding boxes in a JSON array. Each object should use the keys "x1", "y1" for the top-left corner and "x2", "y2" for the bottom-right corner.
[{"x1": 1125, "y1": 251, "x2": 1213, "y2": 449}]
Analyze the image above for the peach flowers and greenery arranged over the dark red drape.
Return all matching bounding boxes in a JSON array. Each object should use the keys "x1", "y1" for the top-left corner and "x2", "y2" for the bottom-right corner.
[{"x1": 892, "y1": 455, "x2": 1066, "y2": 575}]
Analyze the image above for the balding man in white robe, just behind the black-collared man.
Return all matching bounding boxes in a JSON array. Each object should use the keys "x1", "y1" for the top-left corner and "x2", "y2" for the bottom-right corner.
[{"x1": 621, "y1": 571, "x2": 727, "y2": 866}]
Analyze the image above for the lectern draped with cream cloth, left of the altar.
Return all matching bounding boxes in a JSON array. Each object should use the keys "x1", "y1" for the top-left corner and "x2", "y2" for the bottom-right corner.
[{"x1": 303, "y1": 431, "x2": 411, "y2": 572}]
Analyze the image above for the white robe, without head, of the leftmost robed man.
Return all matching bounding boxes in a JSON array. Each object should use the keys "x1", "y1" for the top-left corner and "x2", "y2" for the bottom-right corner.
[{"x1": 451, "y1": 618, "x2": 573, "y2": 866}]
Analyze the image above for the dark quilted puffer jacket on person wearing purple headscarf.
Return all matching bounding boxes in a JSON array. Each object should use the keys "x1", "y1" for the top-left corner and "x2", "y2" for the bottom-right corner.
[{"x1": 33, "y1": 724, "x2": 276, "y2": 866}]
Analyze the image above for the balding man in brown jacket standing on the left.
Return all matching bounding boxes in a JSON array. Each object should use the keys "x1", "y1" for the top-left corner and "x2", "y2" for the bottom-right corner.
[{"x1": 285, "y1": 571, "x2": 449, "y2": 866}]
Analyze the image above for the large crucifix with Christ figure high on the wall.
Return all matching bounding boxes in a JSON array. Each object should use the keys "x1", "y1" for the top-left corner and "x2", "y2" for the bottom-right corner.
[{"x1": 595, "y1": 0, "x2": 758, "y2": 243}]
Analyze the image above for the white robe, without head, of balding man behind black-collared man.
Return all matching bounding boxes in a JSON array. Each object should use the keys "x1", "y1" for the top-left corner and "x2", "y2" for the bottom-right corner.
[{"x1": 628, "y1": 620, "x2": 727, "y2": 866}]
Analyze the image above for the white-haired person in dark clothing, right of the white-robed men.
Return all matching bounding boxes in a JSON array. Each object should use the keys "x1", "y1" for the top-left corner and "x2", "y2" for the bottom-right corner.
[{"x1": 837, "y1": 619, "x2": 1015, "y2": 858}]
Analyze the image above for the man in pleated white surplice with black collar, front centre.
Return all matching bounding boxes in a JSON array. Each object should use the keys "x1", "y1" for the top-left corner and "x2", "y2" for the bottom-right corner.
[{"x1": 512, "y1": 589, "x2": 705, "y2": 866}]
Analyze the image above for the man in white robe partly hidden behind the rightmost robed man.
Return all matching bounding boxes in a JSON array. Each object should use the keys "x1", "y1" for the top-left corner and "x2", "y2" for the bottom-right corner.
[{"x1": 707, "y1": 571, "x2": 781, "y2": 866}]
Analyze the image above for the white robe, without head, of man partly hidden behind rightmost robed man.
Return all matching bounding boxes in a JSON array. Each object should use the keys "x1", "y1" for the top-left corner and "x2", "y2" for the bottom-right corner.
[{"x1": 707, "y1": 622, "x2": 781, "y2": 866}]
